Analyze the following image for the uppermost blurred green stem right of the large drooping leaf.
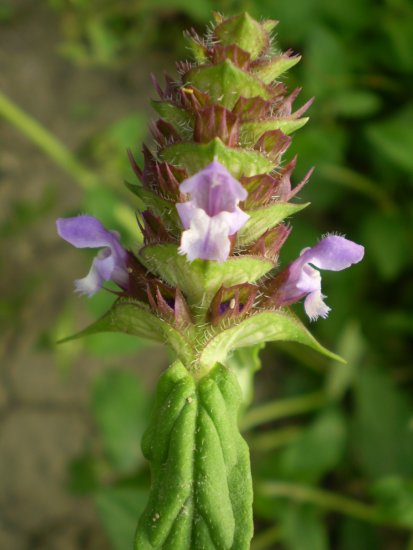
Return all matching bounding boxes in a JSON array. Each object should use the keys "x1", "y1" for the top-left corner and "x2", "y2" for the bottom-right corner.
[{"x1": 241, "y1": 392, "x2": 327, "y2": 430}]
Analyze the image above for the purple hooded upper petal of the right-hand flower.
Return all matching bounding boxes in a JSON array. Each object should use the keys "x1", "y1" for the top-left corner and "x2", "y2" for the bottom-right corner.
[{"x1": 302, "y1": 235, "x2": 364, "y2": 271}]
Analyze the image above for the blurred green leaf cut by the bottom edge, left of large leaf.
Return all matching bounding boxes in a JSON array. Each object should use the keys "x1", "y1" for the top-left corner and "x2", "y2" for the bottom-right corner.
[{"x1": 93, "y1": 488, "x2": 147, "y2": 550}]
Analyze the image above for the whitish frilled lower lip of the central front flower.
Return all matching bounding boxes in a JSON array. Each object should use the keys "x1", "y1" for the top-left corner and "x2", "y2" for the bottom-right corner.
[{"x1": 179, "y1": 208, "x2": 231, "y2": 262}]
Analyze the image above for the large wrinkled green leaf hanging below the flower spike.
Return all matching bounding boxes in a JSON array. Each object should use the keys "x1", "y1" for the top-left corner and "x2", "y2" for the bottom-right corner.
[{"x1": 135, "y1": 362, "x2": 253, "y2": 550}]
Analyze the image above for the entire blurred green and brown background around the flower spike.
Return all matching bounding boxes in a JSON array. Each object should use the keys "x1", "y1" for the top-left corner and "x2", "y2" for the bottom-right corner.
[{"x1": 0, "y1": 0, "x2": 413, "y2": 550}]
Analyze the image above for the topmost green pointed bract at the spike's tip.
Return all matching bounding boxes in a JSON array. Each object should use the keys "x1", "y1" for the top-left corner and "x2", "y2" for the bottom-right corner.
[{"x1": 214, "y1": 12, "x2": 269, "y2": 59}]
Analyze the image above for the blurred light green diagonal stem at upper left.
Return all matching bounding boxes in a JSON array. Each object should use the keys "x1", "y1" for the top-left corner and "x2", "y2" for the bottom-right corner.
[{"x1": 0, "y1": 92, "x2": 98, "y2": 190}]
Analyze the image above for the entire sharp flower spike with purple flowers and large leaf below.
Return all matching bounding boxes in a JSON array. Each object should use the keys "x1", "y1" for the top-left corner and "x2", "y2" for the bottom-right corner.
[{"x1": 57, "y1": 13, "x2": 364, "y2": 550}]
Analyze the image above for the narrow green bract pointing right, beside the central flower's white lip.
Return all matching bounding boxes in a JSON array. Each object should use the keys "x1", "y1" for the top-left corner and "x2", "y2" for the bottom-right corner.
[{"x1": 237, "y1": 202, "x2": 310, "y2": 246}]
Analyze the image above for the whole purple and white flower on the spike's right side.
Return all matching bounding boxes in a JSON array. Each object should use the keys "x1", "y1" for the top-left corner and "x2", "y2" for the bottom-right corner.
[{"x1": 276, "y1": 235, "x2": 364, "y2": 321}]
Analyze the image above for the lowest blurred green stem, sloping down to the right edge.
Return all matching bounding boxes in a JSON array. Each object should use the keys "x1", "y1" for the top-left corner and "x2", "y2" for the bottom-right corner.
[{"x1": 256, "y1": 482, "x2": 408, "y2": 528}]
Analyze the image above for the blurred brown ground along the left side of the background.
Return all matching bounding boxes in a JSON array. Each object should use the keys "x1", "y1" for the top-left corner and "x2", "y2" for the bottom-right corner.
[{"x1": 0, "y1": 0, "x2": 166, "y2": 550}]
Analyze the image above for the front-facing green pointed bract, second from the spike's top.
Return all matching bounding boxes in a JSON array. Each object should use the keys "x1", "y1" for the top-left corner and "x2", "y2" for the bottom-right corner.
[{"x1": 185, "y1": 59, "x2": 271, "y2": 110}]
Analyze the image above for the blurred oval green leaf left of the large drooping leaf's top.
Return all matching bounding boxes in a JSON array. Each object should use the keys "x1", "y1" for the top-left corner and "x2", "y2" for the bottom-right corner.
[{"x1": 91, "y1": 369, "x2": 148, "y2": 471}]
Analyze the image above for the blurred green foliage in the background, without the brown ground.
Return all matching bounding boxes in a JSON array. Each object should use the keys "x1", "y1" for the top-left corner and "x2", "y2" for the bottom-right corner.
[{"x1": 0, "y1": 0, "x2": 413, "y2": 550}]
